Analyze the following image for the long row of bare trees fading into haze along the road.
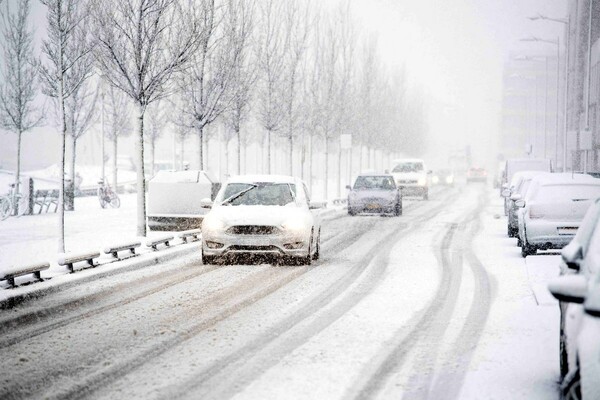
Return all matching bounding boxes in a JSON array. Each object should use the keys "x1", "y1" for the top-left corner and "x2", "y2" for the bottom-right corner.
[{"x1": 0, "y1": 0, "x2": 426, "y2": 251}]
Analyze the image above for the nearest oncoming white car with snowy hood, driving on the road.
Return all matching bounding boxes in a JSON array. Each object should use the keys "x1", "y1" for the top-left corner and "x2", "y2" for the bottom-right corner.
[{"x1": 202, "y1": 175, "x2": 325, "y2": 264}]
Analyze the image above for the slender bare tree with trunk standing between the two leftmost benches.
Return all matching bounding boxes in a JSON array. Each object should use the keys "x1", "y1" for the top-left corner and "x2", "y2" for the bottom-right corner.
[{"x1": 41, "y1": 0, "x2": 92, "y2": 252}]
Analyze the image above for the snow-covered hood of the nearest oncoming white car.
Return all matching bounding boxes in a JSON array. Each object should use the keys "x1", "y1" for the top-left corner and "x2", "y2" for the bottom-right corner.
[{"x1": 206, "y1": 204, "x2": 307, "y2": 226}]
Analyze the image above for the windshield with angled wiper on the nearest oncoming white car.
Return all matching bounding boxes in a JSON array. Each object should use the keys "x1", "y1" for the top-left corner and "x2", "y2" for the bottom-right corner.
[{"x1": 222, "y1": 182, "x2": 296, "y2": 206}]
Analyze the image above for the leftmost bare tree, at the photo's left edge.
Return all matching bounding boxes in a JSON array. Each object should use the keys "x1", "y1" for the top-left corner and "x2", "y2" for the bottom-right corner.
[{"x1": 0, "y1": 0, "x2": 43, "y2": 213}]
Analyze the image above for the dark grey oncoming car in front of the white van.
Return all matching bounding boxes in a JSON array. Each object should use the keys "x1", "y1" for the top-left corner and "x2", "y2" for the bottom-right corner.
[{"x1": 346, "y1": 174, "x2": 402, "y2": 216}]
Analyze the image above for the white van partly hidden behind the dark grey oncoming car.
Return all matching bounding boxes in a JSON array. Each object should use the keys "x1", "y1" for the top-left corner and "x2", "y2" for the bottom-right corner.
[{"x1": 392, "y1": 158, "x2": 431, "y2": 200}]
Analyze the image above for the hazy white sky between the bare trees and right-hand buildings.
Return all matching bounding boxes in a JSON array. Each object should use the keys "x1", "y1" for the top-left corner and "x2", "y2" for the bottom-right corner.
[{"x1": 352, "y1": 0, "x2": 567, "y2": 168}]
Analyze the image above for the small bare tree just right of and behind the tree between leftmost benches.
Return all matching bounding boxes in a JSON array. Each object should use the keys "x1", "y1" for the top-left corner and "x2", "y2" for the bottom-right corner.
[{"x1": 65, "y1": 77, "x2": 98, "y2": 203}]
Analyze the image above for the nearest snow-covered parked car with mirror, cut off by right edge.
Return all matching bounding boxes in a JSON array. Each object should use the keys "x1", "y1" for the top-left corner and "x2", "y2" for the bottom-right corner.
[{"x1": 548, "y1": 199, "x2": 600, "y2": 399}]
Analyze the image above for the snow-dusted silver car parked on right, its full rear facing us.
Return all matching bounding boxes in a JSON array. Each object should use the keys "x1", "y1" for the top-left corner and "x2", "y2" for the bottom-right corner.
[{"x1": 515, "y1": 173, "x2": 600, "y2": 257}]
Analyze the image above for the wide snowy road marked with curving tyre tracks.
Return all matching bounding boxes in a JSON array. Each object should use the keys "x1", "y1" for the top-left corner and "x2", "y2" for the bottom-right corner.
[{"x1": 0, "y1": 185, "x2": 558, "y2": 399}]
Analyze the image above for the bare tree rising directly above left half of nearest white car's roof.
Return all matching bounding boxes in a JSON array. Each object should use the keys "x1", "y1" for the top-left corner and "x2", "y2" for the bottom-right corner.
[{"x1": 224, "y1": 0, "x2": 257, "y2": 174}]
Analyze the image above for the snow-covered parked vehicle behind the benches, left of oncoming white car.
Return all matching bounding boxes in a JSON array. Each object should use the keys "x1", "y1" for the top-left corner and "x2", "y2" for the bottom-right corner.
[{"x1": 148, "y1": 170, "x2": 219, "y2": 230}]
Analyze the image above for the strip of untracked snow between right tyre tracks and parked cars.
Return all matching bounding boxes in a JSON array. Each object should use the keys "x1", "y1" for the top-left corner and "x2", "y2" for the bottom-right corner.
[{"x1": 458, "y1": 189, "x2": 560, "y2": 400}]
